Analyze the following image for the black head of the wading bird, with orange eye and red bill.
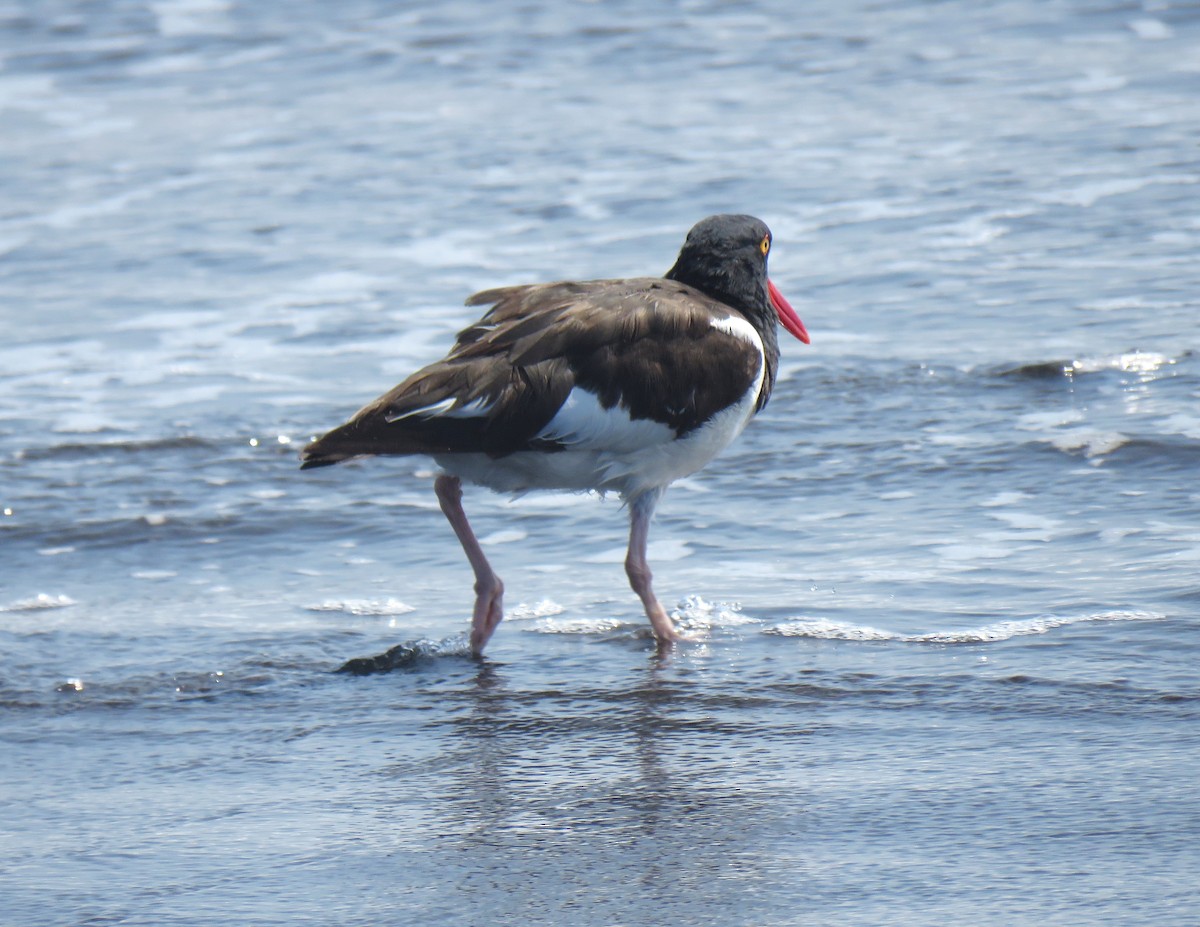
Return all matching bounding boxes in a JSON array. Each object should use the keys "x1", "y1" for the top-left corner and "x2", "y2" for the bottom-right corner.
[{"x1": 666, "y1": 215, "x2": 809, "y2": 343}]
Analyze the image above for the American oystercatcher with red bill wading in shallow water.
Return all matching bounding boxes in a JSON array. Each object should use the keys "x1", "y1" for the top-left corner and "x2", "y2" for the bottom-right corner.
[{"x1": 301, "y1": 215, "x2": 809, "y2": 657}]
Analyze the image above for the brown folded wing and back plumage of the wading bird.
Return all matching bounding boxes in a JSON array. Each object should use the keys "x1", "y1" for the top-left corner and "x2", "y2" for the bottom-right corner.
[{"x1": 304, "y1": 277, "x2": 762, "y2": 467}]
